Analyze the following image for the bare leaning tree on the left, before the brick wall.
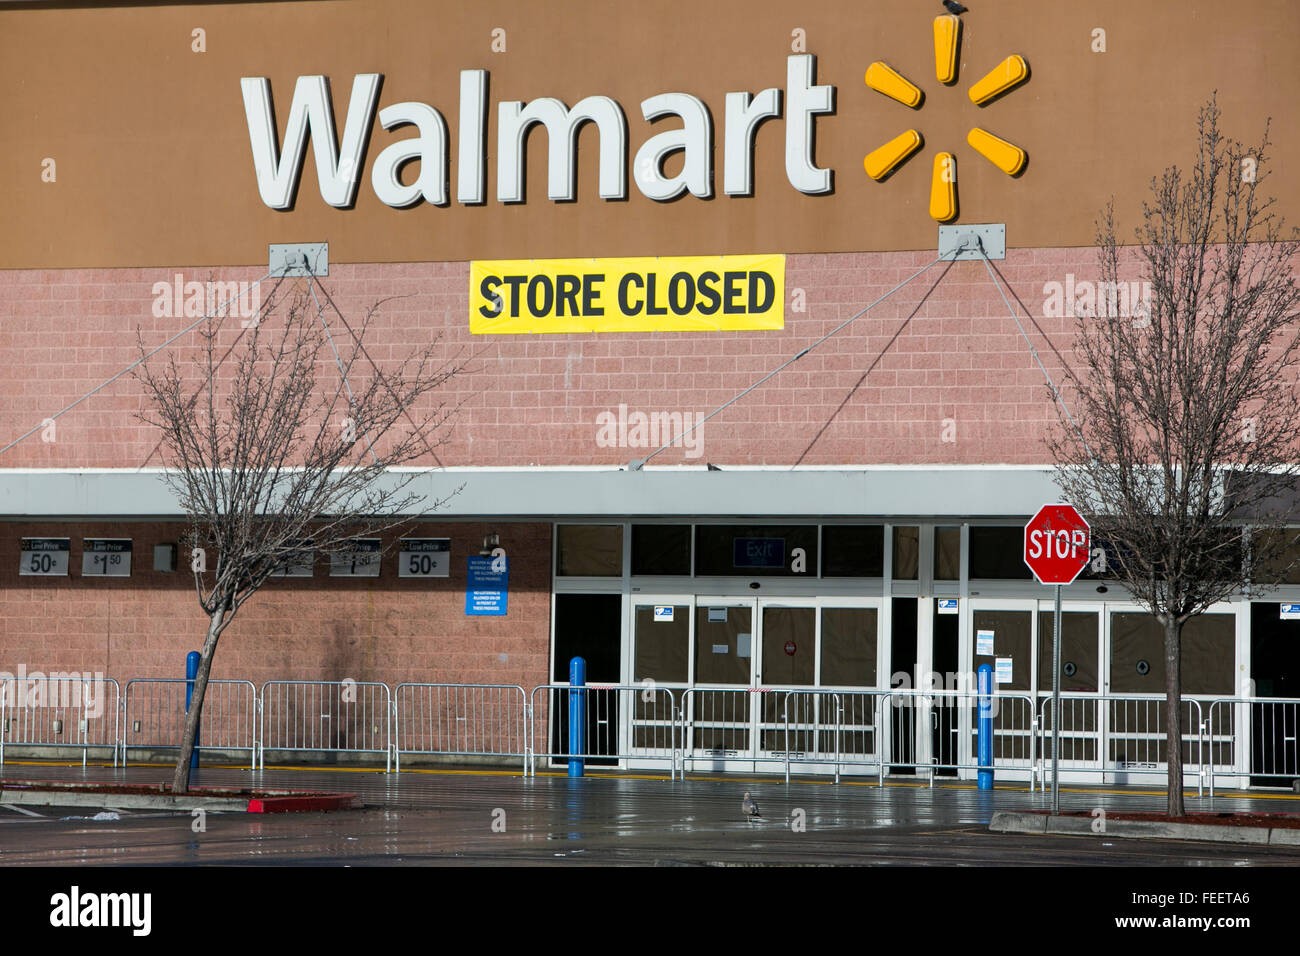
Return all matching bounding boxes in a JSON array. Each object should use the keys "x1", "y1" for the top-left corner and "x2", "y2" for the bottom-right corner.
[{"x1": 135, "y1": 280, "x2": 463, "y2": 793}]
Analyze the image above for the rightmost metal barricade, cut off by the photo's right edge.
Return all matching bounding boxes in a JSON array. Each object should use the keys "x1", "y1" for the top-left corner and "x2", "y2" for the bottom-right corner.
[{"x1": 1206, "y1": 697, "x2": 1300, "y2": 797}]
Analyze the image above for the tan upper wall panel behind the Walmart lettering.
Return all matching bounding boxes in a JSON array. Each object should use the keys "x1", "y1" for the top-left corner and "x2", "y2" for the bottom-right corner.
[{"x1": 0, "y1": 0, "x2": 1300, "y2": 268}]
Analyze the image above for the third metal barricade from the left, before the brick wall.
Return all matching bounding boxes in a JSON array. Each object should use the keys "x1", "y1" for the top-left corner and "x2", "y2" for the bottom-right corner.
[{"x1": 256, "y1": 680, "x2": 394, "y2": 773}]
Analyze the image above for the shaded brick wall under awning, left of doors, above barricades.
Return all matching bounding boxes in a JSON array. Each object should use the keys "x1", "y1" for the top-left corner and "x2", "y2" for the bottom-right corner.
[{"x1": 0, "y1": 522, "x2": 551, "y2": 688}]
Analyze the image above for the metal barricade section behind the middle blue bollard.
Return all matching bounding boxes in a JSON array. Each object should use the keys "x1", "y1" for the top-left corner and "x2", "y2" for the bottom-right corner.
[{"x1": 529, "y1": 683, "x2": 680, "y2": 778}]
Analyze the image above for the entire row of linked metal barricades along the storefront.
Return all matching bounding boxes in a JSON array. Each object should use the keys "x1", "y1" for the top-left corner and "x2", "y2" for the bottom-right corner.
[{"x1": 0, "y1": 674, "x2": 1300, "y2": 796}]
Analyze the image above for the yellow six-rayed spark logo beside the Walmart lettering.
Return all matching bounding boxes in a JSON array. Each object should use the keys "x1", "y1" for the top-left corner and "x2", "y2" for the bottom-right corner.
[{"x1": 862, "y1": 14, "x2": 1030, "y2": 222}]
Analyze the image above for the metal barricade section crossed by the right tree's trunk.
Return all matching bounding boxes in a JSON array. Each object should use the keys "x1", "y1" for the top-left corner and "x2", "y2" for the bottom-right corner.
[{"x1": 1039, "y1": 693, "x2": 1205, "y2": 795}]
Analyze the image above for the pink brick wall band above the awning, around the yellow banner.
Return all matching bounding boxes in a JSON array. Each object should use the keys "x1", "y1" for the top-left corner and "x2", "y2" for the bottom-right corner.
[{"x1": 0, "y1": 248, "x2": 1138, "y2": 467}]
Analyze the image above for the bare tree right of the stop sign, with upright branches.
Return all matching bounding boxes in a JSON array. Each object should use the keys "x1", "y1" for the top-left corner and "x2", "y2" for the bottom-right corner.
[{"x1": 1049, "y1": 99, "x2": 1300, "y2": 816}]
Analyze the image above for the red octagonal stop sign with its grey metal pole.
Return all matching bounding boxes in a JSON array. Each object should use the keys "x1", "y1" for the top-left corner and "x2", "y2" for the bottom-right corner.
[{"x1": 1024, "y1": 503, "x2": 1091, "y2": 813}]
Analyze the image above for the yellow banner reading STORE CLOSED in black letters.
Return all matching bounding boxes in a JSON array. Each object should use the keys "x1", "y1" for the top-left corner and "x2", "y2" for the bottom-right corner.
[{"x1": 469, "y1": 255, "x2": 785, "y2": 336}]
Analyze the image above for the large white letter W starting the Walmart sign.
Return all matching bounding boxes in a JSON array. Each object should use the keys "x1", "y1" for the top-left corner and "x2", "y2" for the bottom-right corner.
[{"x1": 239, "y1": 73, "x2": 381, "y2": 209}]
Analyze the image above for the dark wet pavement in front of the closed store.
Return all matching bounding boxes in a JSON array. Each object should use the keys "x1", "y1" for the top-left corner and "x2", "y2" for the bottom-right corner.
[{"x1": 0, "y1": 763, "x2": 1300, "y2": 866}]
